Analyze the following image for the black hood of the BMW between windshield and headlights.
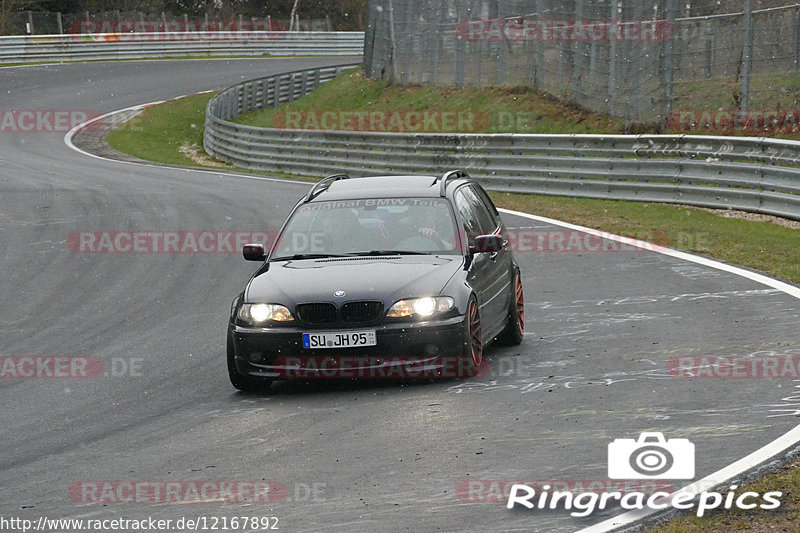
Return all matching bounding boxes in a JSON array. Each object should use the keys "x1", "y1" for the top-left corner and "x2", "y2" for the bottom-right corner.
[{"x1": 245, "y1": 255, "x2": 464, "y2": 305}]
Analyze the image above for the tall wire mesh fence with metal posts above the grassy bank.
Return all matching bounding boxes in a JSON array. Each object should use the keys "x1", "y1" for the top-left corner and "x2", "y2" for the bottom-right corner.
[{"x1": 365, "y1": 0, "x2": 800, "y2": 125}]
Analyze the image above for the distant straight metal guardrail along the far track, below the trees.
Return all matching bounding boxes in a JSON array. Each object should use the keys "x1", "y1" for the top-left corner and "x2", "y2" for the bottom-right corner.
[{"x1": 0, "y1": 31, "x2": 364, "y2": 64}]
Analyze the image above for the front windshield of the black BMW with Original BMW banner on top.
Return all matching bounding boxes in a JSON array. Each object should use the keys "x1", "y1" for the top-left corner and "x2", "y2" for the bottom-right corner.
[{"x1": 271, "y1": 198, "x2": 460, "y2": 261}]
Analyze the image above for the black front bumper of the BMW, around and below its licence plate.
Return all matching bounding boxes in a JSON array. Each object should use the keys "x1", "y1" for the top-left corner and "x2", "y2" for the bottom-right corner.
[{"x1": 229, "y1": 316, "x2": 468, "y2": 379}]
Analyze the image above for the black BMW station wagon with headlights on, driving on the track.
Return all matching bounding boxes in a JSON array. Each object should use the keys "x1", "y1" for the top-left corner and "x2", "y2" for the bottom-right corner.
[{"x1": 227, "y1": 171, "x2": 525, "y2": 391}]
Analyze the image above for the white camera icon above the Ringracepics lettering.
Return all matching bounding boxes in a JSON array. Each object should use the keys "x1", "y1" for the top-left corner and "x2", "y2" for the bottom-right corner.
[{"x1": 608, "y1": 432, "x2": 694, "y2": 479}]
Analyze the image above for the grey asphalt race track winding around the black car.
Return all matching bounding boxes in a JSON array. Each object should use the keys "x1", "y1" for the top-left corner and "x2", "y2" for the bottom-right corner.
[{"x1": 0, "y1": 58, "x2": 800, "y2": 532}]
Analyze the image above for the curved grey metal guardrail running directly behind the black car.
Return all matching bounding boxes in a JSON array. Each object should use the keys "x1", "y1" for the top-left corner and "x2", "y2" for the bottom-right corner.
[{"x1": 204, "y1": 67, "x2": 800, "y2": 220}]
